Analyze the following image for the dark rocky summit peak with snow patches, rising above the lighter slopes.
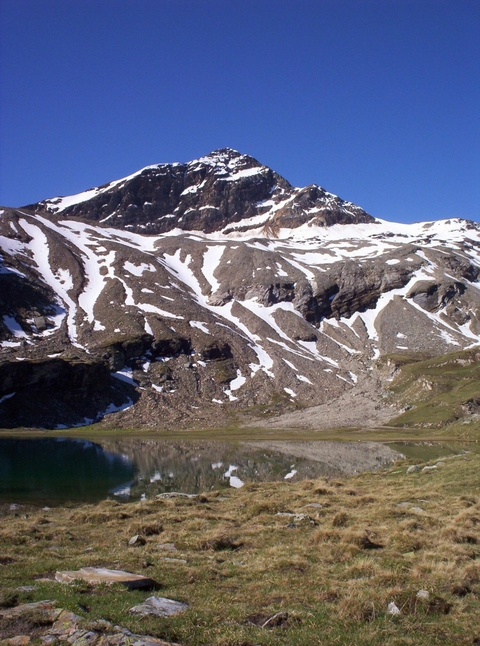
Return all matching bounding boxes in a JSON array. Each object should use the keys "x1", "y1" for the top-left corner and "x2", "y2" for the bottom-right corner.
[{"x1": 25, "y1": 148, "x2": 374, "y2": 234}]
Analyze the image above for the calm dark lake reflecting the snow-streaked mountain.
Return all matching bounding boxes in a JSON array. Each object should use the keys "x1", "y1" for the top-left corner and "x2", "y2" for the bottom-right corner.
[{"x1": 0, "y1": 437, "x2": 464, "y2": 505}]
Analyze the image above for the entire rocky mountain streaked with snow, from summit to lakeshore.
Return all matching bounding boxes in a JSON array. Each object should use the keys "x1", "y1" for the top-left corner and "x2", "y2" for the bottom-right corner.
[{"x1": 0, "y1": 149, "x2": 480, "y2": 428}]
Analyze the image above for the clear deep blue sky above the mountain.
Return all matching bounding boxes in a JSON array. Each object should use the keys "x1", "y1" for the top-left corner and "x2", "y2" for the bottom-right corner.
[{"x1": 0, "y1": 0, "x2": 480, "y2": 222}]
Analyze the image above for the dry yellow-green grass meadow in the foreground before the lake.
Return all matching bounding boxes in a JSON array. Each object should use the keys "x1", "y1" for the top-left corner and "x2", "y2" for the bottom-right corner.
[{"x1": 0, "y1": 453, "x2": 480, "y2": 646}]
